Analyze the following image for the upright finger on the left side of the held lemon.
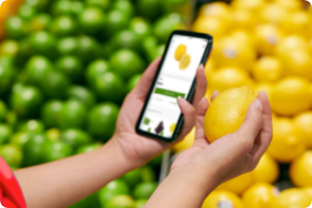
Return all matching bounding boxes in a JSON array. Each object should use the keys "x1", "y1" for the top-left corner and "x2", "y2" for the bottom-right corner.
[{"x1": 194, "y1": 97, "x2": 209, "y2": 147}]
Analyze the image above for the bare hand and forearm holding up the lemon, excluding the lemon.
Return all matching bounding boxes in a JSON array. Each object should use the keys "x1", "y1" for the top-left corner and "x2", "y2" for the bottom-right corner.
[{"x1": 145, "y1": 93, "x2": 272, "y2": 208}]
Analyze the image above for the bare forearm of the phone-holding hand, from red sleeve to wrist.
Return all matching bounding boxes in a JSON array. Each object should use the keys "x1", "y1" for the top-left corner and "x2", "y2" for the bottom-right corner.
[{"x1": 15, "y1": 140, "x2": 138, "y2": 208}]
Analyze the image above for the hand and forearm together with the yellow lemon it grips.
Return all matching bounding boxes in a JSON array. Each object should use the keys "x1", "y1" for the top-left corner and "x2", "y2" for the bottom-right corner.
[{"x1": 146, "y1": 87, "x2": 272, "y2": 207}]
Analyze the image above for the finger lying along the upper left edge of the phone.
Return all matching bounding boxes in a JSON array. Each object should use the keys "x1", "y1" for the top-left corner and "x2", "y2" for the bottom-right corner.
[{"x1": 131, "y1": 58, "x2": 161, "y2": 98}]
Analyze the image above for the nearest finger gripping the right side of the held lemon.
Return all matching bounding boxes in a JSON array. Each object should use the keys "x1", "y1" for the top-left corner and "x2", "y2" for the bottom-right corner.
[{"x1": 234, "y1": 99, "x2": 263, "y2": 153}]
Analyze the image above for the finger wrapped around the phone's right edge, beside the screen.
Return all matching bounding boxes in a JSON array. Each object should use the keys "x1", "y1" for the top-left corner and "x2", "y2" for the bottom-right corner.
[{"x1": 192, "y1": 64, "x2": 207, "y2": 108}]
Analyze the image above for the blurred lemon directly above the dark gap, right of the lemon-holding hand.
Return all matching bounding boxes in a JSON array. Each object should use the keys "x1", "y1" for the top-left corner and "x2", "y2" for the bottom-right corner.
[{"x1": 267, "y1": 118, "x2": 306, "y2": 163}]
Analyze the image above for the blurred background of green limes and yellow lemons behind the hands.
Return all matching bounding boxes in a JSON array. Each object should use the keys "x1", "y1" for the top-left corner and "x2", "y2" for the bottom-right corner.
[{"x1": 0, "y1": 0, "x2": 312, "y2": 208}]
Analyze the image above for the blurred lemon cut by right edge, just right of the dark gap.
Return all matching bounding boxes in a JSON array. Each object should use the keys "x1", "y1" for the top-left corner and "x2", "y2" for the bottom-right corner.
[{"x1": 289, "y1": 150, "x2": 312, "y2": 187}]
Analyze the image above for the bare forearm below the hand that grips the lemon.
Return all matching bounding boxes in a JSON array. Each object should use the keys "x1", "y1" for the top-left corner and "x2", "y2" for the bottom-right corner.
[{"x1": 144, "y1": 168, "x2": 215, "y2": 208}]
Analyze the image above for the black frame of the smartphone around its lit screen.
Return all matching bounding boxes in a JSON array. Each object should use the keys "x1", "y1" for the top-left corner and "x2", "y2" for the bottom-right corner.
[{"x1": 135, "y1": 30, "x2": 213, "y2": 142}]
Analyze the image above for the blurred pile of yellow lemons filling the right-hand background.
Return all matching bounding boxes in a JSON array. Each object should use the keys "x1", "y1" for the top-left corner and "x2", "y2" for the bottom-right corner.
[{"x1": 174, "y1": 0, "x2": 312, "y2": 208}]
